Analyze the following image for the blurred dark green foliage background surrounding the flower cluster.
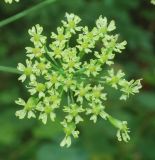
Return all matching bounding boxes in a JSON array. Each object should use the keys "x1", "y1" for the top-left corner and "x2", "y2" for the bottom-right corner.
[{"x1": 0, "y1": 0, "x2": 155, "y2": 160}]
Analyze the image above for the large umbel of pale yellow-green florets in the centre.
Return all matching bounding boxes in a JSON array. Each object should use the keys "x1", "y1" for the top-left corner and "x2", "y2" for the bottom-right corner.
[{"x1": 16, "y1": 13, "x2": 141, "y2": 147}]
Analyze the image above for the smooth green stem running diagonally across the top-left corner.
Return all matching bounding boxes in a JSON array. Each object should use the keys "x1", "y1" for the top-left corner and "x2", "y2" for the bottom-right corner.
[{"x1": 0, "y1": 0, "x2": 55, "y2": 27}]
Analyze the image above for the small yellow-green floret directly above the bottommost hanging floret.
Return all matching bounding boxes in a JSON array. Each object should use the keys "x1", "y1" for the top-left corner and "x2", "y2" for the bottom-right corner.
[{"x1": 63, "y1": 104, "x2": 85, "y2": 124}]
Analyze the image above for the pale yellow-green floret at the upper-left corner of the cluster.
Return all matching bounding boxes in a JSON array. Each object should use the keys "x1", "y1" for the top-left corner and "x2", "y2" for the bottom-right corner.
[{"x1": 28, "y1": 24, "x2": 47, "y2": 47}]
